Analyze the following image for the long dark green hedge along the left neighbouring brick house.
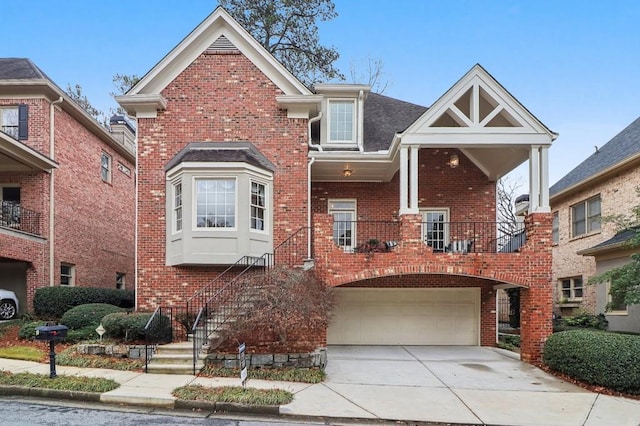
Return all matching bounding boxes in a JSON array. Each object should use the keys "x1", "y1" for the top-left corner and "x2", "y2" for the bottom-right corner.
[{"x1": 33, "y1": 286, "x2": 135, "y2": 319}]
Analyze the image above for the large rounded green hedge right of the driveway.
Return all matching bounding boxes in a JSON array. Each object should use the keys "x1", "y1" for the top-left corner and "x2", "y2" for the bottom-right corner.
[{"x1": 543, "y1": 330, "x2": 640, "y2": 394}]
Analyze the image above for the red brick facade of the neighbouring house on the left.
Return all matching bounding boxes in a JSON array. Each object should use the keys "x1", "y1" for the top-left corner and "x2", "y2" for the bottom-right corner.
[{"x1": 0, "y1": 94, "x2": 135, "y2": 312}]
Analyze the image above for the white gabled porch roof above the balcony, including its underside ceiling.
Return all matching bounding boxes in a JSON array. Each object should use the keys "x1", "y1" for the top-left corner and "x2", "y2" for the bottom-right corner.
[{"x1": 397, "y1": 64, "x2": 558, "y2": 180}]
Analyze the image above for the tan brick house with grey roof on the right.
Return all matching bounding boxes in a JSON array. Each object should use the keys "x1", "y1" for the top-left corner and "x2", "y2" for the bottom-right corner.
[{"x1": 550, "y1": 118, "x2": 640, "y2": 331}]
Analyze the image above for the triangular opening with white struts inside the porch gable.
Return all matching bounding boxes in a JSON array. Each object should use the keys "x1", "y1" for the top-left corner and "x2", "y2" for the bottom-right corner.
[{"x1": 429, "y1": 83, "x2": 523, "y2": 127}]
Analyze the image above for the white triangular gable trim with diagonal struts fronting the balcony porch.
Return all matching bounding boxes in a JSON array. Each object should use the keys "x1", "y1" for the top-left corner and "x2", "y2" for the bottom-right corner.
[{"x1": 399, "y1": 64, "x2": 557, "y2": 145}]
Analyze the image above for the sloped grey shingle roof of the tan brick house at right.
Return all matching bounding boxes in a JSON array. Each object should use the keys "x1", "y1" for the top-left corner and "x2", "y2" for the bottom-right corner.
[{"x1": 549, "y1": 117, "x2": 640, "y2": 197}]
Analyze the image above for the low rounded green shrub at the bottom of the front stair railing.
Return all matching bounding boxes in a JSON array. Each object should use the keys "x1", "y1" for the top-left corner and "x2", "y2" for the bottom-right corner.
[{"x1": 102, "y1": 312, "x2": 172, "y2": 342}]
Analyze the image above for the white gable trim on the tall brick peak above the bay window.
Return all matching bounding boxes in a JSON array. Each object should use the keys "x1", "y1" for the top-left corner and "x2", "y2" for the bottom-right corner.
[{"x1": 125, "y1": 7, "x2": 311, "y2": 96}]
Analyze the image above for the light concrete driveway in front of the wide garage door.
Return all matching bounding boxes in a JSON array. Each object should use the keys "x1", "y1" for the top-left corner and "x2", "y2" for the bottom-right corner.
[{"x1": 281, "y1": 346, "x2": 640, "y2": 426}]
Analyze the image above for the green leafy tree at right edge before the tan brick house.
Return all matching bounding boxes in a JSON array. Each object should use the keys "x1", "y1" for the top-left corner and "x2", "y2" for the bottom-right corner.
[{"x1": 589, "y1": 186, "x2": 640, "y2": 310}]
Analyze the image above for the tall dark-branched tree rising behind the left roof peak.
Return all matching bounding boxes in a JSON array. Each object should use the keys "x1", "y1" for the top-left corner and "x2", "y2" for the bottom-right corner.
[{"x1": 220, "y1": 0, "x2": 344, "y2": 86}]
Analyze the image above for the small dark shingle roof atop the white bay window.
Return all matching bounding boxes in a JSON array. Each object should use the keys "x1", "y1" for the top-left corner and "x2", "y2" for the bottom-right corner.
[{"x1": 164, "y1": 142, "x2": 276, "y2": 172}]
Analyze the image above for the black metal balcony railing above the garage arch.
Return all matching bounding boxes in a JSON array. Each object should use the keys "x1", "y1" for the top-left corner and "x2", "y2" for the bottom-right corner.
[{"x1": 332, "y1": 220, "x2": 526, "y2": 253}]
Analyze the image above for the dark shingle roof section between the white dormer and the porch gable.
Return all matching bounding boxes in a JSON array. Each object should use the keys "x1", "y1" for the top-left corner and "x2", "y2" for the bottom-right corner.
[{"x1": 364, "y1": 93, "x2": 427, "y2": 152}]
